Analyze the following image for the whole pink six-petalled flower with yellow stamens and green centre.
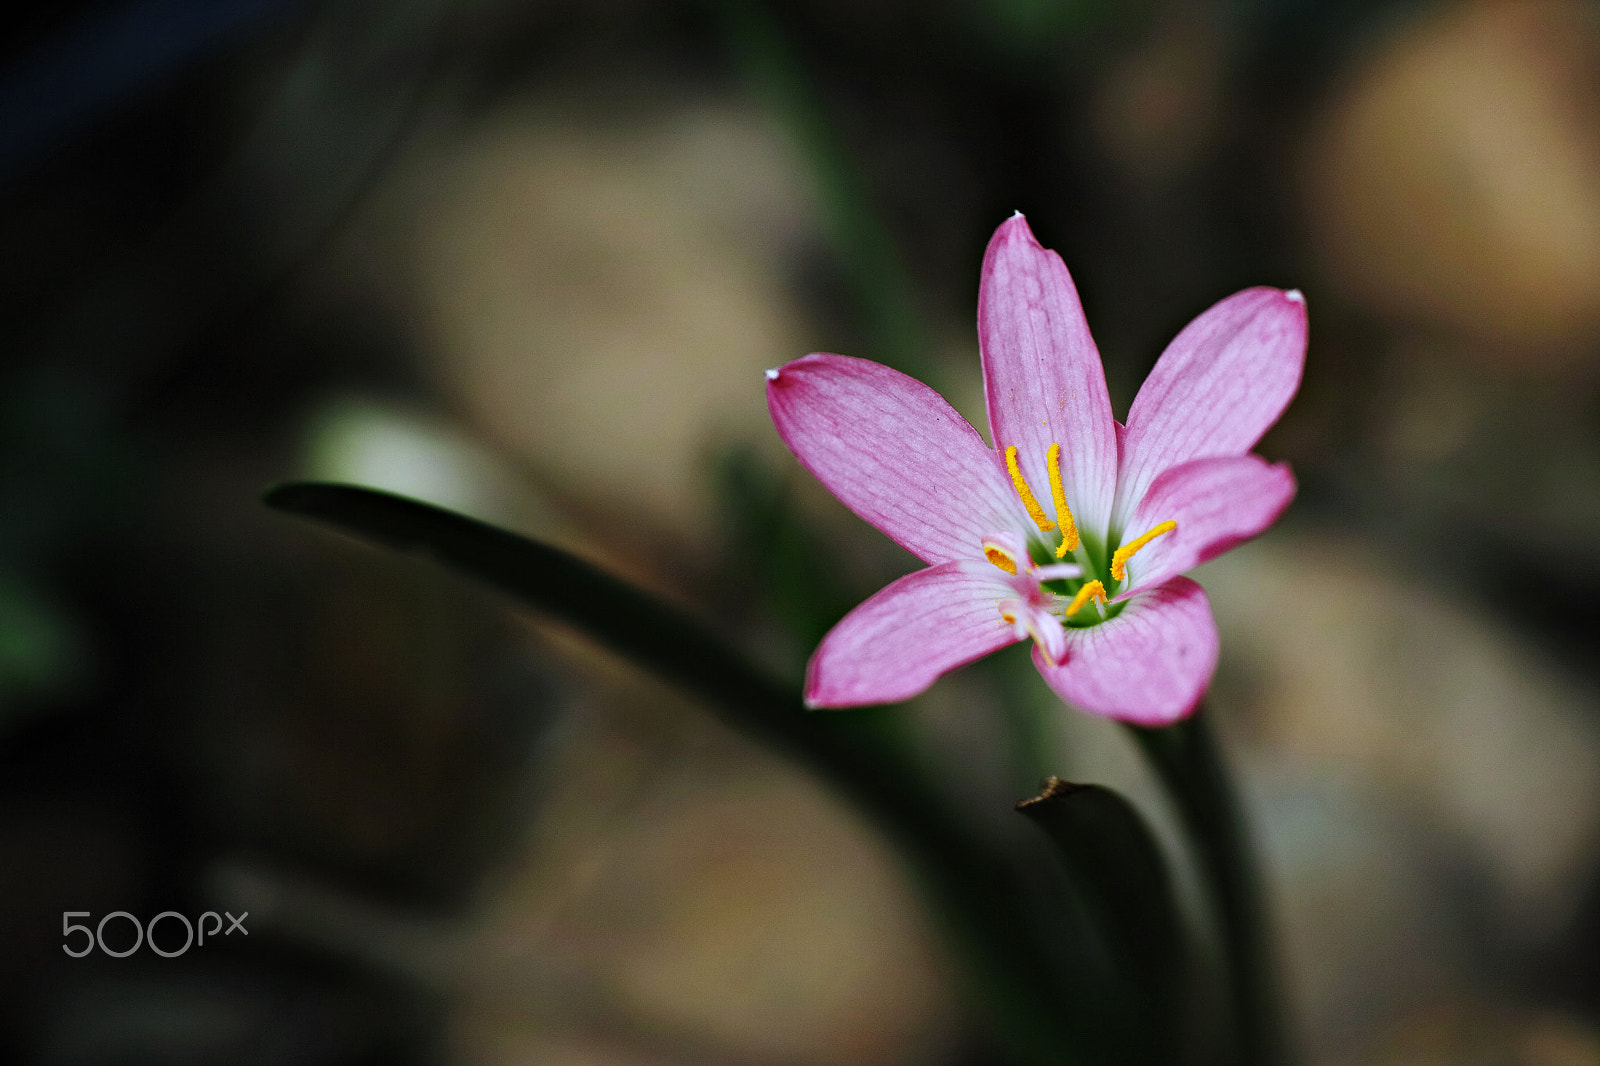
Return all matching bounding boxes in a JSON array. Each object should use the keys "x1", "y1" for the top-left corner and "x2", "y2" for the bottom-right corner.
[{"x1": 766, "y1": 213, "x2": 1306, "y2": 725}]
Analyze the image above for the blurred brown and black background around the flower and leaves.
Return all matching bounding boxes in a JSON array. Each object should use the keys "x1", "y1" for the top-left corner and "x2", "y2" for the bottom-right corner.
[{"x1": 0, "y1": 0, "x2": 1600, "y2": 1066}]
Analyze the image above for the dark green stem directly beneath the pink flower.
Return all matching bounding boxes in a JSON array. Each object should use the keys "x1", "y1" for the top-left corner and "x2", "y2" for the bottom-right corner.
[{"x1": 1130, "y1": 706, "x2": 1288, "y2": 1066}]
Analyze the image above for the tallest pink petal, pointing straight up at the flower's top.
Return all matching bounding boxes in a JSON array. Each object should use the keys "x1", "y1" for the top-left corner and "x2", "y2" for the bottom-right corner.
[{"x1": 978, "y1": 214, "x2": 1117, "y2": 538}]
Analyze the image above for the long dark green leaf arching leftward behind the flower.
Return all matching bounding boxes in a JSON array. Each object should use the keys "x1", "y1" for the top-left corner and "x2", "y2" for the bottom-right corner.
[{"x1": 266, "y1": 483, "x2": 1141, "y2": 1066}]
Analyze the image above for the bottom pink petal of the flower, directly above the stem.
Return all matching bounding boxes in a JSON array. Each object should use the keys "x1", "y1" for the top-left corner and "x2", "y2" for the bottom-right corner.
[{"x1": 1034, "y1": 578, "x2": 1218, "y2": 725}]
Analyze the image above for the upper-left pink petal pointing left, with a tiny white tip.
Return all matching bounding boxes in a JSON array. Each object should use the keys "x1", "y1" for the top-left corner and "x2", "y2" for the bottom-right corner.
[{"x1": 766, "y1": 355, "x2": 1029, "y2": 563}]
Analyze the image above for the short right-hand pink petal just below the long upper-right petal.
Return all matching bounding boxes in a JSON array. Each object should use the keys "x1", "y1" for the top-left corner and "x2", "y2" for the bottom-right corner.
[{"x1": 1123, "y1": 455, "x2": 1294, "y2": 589}]
